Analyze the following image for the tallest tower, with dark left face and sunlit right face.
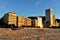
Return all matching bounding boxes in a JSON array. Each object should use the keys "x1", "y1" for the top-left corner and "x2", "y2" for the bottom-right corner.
[{"x1": 45, "y1": 8, "x2": 55, "y2": 27}]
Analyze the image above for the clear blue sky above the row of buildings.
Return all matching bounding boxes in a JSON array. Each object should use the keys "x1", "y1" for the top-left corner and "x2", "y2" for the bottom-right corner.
[{"x1": 0, "y1": 0, "x2": 60, "y2": 18}]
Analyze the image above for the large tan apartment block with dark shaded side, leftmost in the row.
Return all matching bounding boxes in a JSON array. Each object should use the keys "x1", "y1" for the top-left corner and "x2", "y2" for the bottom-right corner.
[{"x1": 2, "y1": 12, "x2": 16, "y2": 26}]
